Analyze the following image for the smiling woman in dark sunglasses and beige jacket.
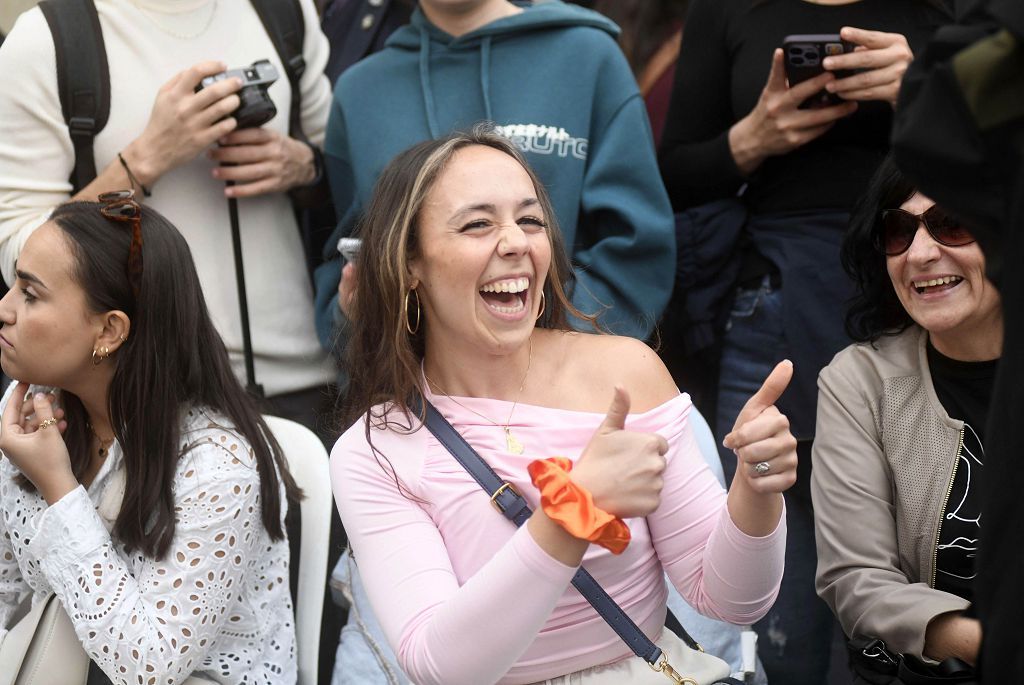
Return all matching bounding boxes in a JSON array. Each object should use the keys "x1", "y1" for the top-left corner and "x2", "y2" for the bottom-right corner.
[{"x1": 811, "y1": 159, "x2": 1002, "y2": 682}]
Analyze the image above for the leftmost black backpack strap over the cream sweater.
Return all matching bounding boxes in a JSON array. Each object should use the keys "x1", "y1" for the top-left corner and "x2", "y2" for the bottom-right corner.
[{"x1": 39, "y1": 0, "x2": 111, "y2": 195}]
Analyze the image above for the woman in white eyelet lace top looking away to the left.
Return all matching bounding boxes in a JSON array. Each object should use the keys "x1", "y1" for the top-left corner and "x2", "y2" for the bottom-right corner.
[{"x1": 0, "y1": 192, "x2": 296, "y2": 685}]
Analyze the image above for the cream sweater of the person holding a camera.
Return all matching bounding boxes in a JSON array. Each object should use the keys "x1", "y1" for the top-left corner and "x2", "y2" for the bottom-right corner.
[{"x1": 0, "y1": 0, "x2": 332, "y2": 395}]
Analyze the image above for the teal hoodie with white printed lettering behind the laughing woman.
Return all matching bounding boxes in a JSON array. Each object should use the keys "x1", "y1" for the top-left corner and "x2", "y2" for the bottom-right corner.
[{"x1": 316, "y1": 1, "x2": 676, "y2": 338}]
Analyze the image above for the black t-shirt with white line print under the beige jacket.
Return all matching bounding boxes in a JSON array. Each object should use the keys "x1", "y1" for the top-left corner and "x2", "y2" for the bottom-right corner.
[{"x1": 928, "y1": 344, "x2": 998, "y2": 601}]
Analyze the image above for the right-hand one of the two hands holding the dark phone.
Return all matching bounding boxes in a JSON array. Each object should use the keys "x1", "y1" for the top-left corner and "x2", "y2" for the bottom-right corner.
[{"x1": 823, "y1": 27, "x2": 913, "y2": 106}]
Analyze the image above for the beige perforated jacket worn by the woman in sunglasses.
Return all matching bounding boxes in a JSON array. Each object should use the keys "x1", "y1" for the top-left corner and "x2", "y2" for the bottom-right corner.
[{"x1": 811, "y1": 327, "x2": 968, "y2": 656}]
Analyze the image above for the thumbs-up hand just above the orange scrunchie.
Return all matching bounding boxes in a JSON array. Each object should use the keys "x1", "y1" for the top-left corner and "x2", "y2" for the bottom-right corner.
[{"x1": 570, "y1": 386, "x2": 669, "y2": 518}]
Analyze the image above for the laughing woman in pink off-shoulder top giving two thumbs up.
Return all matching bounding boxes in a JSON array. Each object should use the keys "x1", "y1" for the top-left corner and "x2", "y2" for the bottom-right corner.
[{"x1": 331, "y1": 124, "x2": 797, "y2": 685}]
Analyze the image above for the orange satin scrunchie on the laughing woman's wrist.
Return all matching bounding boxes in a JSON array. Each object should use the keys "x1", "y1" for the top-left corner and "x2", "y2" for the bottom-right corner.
[{"x1": 526, "y1": 457, "x2": 630, "y2": 554}]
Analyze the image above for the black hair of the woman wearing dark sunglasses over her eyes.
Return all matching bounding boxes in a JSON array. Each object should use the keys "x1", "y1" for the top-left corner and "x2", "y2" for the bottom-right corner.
[{"x1": 840, "y1": 155, "x2": 916, "y2": 342}]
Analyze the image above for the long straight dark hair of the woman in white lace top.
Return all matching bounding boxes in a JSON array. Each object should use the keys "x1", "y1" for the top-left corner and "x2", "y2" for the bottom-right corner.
[{"x1": 44, "y1": 202, "x2": 301, "y2": 559}]
